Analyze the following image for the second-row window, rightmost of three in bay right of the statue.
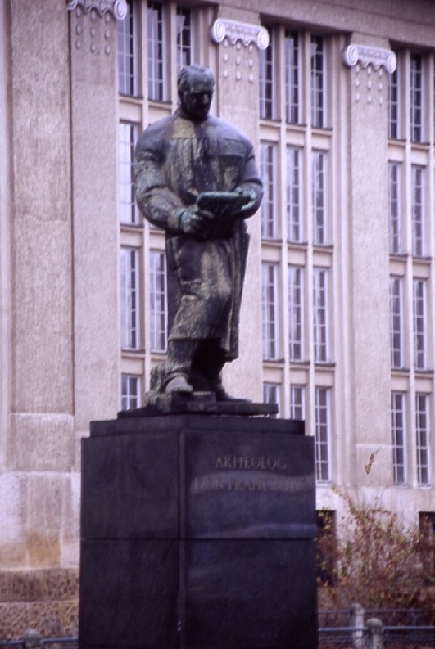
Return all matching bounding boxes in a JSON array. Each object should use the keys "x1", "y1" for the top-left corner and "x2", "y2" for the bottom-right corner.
[{"x1": 311, "y1": 151, "x2": 328, "y2": 246}]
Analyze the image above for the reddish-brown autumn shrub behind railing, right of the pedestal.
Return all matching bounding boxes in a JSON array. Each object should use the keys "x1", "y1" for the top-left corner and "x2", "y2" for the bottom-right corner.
[{"x1": 317, "y1": 493, "x2": 435, "y2": 624}]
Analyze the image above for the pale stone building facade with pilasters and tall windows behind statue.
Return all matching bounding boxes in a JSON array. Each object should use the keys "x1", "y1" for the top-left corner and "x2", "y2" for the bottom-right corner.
[{"x1": 0, "y1": 0, "x2": 435, "y2": 638}]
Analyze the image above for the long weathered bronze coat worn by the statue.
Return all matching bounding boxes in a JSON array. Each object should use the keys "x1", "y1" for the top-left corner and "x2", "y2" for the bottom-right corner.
[{"x1": 134, "y1": 110, "x2": 262, "y2": 360}]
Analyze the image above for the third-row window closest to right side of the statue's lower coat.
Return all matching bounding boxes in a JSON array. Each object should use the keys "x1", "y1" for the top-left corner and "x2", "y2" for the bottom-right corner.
[{"x1": 261, "y1": 263, "x2": 279, "y2": 360}]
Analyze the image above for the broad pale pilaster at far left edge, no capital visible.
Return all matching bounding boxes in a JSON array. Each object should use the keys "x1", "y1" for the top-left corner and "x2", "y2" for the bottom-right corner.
[{"x1": 8, "y1": 0, "x2": 73, "y2": 460}]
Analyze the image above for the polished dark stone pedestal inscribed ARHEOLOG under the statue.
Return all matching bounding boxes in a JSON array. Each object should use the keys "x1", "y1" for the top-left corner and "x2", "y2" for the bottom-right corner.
[{"x1": 79, "y1": 414, "x2": 317, "y2": 649}]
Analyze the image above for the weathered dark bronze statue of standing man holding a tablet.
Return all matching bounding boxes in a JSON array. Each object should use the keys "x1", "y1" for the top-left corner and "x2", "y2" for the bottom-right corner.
[{"x1": 134, "y1": 65, "x2": 262, "y2": 401}]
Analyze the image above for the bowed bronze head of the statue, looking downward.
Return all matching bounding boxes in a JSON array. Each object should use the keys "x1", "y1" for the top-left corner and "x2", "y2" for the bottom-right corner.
[{"x1": 178, "y1": 65, "x2": 214, "y2": 122}]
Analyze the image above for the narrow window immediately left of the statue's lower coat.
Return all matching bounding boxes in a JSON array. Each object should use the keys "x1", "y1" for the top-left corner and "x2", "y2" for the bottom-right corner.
[{"x1": 150, "y1": 250, "x2": 168, "y2": 352}]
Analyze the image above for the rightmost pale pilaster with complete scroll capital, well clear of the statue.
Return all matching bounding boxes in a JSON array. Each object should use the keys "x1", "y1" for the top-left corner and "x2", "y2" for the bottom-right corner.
[{"x1": 343, "y1": 41, "x2": 395, "y2": 494}]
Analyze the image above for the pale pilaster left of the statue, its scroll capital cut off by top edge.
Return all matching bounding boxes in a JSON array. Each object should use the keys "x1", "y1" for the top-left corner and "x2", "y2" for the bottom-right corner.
[{"x1": 68, "y1": 0, "x2": 121, "y2": 436}]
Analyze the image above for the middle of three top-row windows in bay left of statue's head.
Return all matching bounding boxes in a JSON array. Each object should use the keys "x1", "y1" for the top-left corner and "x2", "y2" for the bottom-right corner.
[{"x1": 147, "y1": 0, "x2": 166, "y2": 101}]
